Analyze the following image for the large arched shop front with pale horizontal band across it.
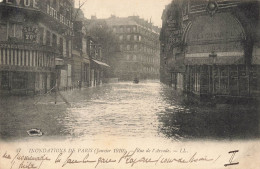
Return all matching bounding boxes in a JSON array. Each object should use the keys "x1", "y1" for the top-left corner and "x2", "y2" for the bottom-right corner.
[{"x1": 185, "y1": 12, "x2": 255, "y2": 96}]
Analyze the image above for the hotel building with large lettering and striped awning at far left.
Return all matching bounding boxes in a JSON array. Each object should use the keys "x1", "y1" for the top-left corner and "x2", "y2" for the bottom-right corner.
[{"x1": 0, "y1": 0, "x2": 74, "y2": 94}]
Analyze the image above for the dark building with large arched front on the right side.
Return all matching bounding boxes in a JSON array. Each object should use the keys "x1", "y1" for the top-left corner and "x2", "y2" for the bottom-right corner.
[{"x1": 160, "y1": 0, "x2": 260, "y2": 98}]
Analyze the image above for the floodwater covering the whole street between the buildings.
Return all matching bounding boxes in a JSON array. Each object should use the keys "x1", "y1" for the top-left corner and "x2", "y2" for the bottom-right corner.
[{"x1": 0, "y1": 81, "x2": 259, "y2": 141}]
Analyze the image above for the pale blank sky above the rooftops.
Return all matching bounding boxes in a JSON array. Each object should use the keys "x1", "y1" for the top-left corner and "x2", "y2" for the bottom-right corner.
[{"x1": 75, "y1": 0, "x2": 172, "y2": 27}]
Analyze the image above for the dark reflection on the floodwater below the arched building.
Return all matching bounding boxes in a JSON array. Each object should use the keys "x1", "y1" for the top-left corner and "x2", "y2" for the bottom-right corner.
[{"x1": 158, "y1": 88, "x2": 259, "y2": 140}]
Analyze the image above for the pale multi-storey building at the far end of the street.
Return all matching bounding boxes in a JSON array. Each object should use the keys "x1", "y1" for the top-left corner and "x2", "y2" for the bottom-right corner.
[{"x1": 89, "y1": 16, "x2": 160, "y2": 80}]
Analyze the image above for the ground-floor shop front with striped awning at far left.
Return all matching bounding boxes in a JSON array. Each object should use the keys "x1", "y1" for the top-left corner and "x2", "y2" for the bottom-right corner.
[{"x1": 0, "y1": 42, "x2": 55, "y2": 94}]
